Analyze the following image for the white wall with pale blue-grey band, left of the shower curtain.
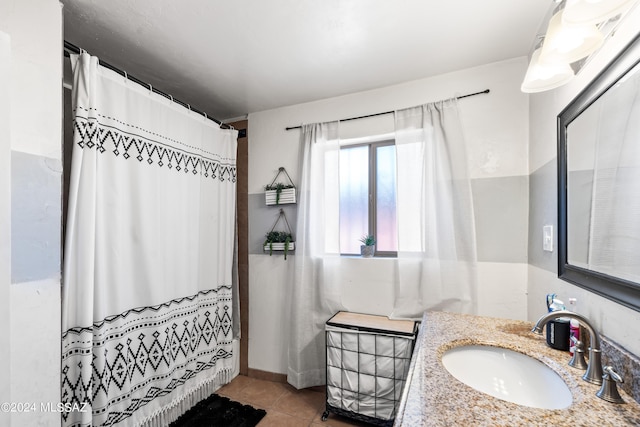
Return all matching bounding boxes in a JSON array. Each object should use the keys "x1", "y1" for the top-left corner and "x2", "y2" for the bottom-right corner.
[{"x1": 0, "y1": 0, "x2": 62, "y2": 426}]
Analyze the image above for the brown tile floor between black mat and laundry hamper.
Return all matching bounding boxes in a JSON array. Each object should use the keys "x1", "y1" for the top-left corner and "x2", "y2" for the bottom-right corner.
[{"x1": 217, "y1": 375, "x2": 369, "y2": 427}]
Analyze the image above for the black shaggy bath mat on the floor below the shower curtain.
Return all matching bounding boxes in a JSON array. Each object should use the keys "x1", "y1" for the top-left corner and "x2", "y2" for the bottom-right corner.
[{"x1": 169, "y1": 394, "x2": 267, "y2": 427}]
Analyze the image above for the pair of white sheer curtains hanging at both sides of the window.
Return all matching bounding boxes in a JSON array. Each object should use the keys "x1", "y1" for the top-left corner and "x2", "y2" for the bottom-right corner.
[{"x1": 288, "y1": 100, "x2": 477, "y2": 388}]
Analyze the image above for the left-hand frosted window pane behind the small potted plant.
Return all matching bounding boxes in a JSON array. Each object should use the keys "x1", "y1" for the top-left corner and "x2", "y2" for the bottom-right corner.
[{"x1": 340, "y1": 146, "x2": 369, "y2": 254}]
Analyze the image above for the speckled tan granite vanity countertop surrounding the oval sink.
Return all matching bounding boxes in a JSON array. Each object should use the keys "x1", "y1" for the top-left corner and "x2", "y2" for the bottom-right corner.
[{"x1": 394, "y1": 312, "x2": 640, "y2": 427}]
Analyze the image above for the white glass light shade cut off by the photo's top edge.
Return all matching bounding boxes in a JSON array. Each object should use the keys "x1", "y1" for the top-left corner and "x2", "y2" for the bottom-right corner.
[{"x1": 562, "y1": 0, "x2": 637, "y2": 25}]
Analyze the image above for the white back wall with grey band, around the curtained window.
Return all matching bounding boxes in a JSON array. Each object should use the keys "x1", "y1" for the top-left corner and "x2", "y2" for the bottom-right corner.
[{"x1": 249, "y1": 58, "x2": 529, "y2": 373}]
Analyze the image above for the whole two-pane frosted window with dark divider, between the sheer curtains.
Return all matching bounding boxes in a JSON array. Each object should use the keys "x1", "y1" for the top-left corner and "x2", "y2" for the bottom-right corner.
[{"x1": 340, "y1": 141, "x2": 398, "y2": 256}]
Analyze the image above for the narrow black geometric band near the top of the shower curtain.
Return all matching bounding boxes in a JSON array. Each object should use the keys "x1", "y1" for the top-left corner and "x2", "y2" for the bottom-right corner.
[{"x1": 73, "y1": 115, "x2": 237, "y2": 182}]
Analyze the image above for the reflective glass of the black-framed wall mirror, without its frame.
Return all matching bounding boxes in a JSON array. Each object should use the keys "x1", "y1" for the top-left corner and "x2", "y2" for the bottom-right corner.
[{"x1": 567, "y1": 61, "x2": 640, "y2": 282}]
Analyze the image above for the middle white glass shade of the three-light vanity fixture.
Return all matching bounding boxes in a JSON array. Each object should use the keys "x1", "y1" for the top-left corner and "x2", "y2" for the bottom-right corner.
[{"x1": 540, "y1": 9, "x2": 604, "y2": 64}]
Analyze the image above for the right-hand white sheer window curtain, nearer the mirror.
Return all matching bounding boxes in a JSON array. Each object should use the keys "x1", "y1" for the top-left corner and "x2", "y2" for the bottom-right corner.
[{"x1": 391, "y1": 99, "x2": 477, "y2": 318}]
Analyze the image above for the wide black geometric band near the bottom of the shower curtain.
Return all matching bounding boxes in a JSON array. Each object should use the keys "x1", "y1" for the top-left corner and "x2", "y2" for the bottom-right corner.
[{"x1": 61, "y1": 286, "x2": 233, "y2": 426}]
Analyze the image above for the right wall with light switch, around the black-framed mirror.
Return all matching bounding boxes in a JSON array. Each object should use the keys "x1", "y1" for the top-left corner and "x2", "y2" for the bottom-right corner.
[{"x1": 527, "y1": 7, "x2": 640, "y2": 355}]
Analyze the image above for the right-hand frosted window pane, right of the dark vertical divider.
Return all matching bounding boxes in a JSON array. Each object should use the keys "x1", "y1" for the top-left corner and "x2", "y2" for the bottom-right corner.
[{"x1": 376, "y1": 145, "x2": 398, "y2": 252}]
